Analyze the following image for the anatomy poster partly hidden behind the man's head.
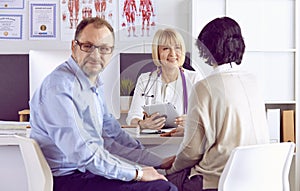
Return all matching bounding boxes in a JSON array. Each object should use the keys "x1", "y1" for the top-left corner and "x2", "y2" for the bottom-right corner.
[{"x1": 60, "y1": 0, "x2": 118, "y2": 41}]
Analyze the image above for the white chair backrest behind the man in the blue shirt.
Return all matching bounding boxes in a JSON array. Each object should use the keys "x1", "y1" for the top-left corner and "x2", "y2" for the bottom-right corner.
[{"x1": 0, "y1": 135, "x2": 53, "y2": 191}]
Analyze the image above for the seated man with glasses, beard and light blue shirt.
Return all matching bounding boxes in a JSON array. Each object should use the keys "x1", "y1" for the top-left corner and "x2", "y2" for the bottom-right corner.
[{"x1": 30, "y1": 17, "x2": 177, "y2": 191}]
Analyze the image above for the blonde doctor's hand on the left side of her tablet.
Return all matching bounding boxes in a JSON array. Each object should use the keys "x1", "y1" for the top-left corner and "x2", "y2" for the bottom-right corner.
[{"x1": 138, "y1": 113, "x2": 166, "y2": 129}]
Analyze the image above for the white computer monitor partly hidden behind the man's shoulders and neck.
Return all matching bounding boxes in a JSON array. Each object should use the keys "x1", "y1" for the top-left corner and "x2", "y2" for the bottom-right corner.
[{"x1": 29, "y1": 50, "x2": 120, "y2": 119}]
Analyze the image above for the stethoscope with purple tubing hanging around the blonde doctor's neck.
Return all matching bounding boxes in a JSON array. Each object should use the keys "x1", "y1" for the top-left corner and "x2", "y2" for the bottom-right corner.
[{"x1": 141, "y1": 67, "x2": 188, "y2": 114}]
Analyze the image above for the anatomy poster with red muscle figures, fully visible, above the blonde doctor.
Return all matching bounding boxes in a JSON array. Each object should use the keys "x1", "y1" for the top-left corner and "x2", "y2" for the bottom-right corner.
[{"x1": 119, "y1": 0, "x2": 157, "y2": 41}]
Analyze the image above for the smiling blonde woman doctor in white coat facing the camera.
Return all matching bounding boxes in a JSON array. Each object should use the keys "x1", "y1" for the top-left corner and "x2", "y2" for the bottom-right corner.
[{"x1": 126, "y1": 28, "x2": 202, "y2": 136}]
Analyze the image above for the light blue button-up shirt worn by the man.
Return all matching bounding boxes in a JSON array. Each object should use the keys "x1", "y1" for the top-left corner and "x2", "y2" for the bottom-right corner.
[{"x1": 30, "y1": 57, "x2": 162, "y2": 181}]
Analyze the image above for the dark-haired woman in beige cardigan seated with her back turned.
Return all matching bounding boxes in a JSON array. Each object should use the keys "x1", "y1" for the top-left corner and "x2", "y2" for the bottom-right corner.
[{"x1": 166, "y1": 17, "x2": 269, "y2": 191}]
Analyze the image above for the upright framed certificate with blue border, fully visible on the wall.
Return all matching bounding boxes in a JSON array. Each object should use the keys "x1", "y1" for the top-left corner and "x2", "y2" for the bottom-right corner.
[{"x1": 29, "y1": 2, "x2": 57, "y2": 39}]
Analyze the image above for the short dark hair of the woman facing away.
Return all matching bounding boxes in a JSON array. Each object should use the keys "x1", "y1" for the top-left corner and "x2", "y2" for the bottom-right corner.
[{"x1": 197, "y1": 17, "x2": 245, "y2": 65}]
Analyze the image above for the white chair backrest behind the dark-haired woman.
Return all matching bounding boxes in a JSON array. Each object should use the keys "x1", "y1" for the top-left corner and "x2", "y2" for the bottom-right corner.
[{"x1": 218, "y1": 142, "x2": 295, "y2": 191}]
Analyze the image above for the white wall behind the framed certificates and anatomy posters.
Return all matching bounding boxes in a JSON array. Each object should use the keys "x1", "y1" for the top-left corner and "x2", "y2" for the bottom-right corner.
[{"x1": 0, "y1": 0, "x2": 189, "y2": 54}]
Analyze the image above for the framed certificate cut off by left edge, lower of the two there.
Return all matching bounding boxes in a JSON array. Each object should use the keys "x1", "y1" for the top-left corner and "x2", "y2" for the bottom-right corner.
[{"x1": 0, "y1": 14, "x2": 23, "y2": 40}]
